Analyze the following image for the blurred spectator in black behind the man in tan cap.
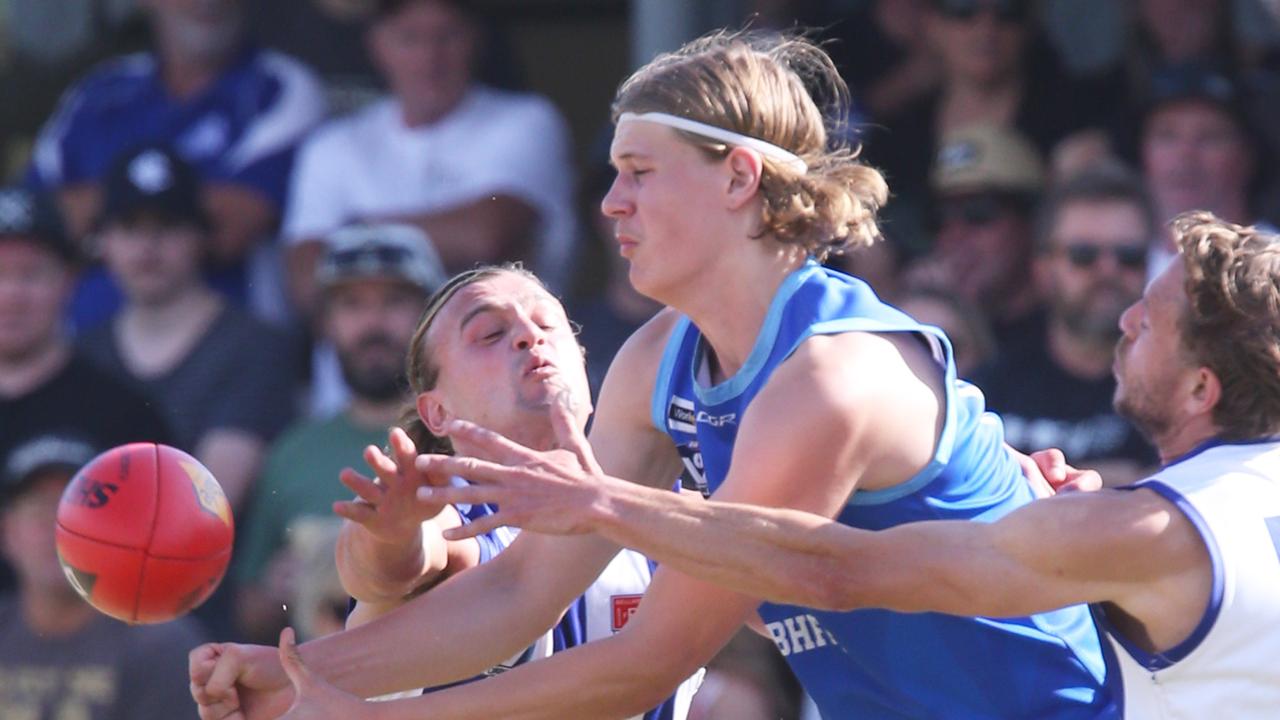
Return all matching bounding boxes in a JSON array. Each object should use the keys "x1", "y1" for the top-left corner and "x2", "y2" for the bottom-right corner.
[{"x1": 867, "y1": 0, "x2": 1106, "y2": 215}]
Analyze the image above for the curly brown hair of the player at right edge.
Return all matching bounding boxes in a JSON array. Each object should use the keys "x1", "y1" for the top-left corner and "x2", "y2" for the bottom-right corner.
[{"x1": 1172, "y1": 211, "x2": 1280, "y2": 439}]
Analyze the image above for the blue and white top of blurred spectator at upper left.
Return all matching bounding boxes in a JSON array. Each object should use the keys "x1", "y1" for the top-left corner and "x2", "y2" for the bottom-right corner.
[{"x1": 26, "y1": 47, "x2": 326, "y2": 327}]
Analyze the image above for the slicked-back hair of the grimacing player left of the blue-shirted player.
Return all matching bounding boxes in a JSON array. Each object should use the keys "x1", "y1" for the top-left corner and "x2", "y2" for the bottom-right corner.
[{"x1": 399, "y1": 263, "x2": 547, "y2": 454}]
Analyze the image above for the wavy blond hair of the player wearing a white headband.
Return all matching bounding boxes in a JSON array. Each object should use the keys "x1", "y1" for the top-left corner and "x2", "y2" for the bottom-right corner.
[{"x1": 613, "y1": 31, "x2": 888, "y2": 260}]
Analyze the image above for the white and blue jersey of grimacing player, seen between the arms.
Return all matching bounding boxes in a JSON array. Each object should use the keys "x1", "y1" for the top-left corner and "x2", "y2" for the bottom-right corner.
[{"x1": 456, "y1": 491, "x2": 703, "y2": 720}]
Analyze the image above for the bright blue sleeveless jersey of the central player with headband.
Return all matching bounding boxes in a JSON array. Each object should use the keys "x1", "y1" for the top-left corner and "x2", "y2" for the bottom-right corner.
[{"x1": 652, "y1": 263, "x2": 1117, "y2": 720}]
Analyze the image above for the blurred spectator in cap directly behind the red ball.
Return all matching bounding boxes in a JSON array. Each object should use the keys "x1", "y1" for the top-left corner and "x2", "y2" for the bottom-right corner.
[{"x1": 0, "y1": 425, "x2": 205, "y2": 720}]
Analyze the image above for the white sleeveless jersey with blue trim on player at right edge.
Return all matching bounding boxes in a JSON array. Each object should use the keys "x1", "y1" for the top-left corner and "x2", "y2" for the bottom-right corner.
[{"x1": 1100, "y1": 441, "x2": 1280, "y2": 720}]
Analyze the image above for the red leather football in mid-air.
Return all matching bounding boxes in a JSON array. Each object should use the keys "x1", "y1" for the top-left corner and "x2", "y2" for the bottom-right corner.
[{"x1": 58, "y1": 442, "x2": 236, "y2": 623}]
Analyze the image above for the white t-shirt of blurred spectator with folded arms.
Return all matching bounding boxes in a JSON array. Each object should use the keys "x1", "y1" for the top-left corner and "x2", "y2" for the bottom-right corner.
[{"x1": 283, "y1": 86, "x2": 577, "y2": 288}]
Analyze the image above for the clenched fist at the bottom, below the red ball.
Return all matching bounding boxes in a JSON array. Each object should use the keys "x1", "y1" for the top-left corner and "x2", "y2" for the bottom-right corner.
[{"x1": 187, "y1": 635, "x2": 293, "y2": 720}]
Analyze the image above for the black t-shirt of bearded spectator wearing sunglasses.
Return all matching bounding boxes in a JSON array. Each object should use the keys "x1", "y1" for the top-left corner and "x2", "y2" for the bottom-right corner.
[{"x1": 973, "y1": 317, "x2": 1156, "y2": 465}]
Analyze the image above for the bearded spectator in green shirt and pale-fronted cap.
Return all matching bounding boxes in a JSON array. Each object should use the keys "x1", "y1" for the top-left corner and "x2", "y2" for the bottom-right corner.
[{"x1": 234, "y1": 224, "x2": 444, "y2": 638}]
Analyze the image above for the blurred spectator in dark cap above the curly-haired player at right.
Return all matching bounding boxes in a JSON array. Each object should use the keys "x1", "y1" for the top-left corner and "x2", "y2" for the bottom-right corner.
[{"x1": 1140, "y1": 65, "x2": 1266, "y2": 266}]
